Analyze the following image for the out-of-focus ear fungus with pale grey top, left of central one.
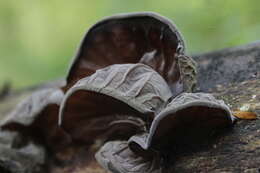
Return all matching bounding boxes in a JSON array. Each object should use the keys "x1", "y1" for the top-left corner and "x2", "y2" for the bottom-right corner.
[{"x1": 1, "y1": 88, "x2": 69, "y2": 149}]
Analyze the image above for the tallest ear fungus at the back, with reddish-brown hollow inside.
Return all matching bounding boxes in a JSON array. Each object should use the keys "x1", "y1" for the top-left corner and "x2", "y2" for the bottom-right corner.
[{"x1": 67, "y1": 12, "x2": 196, "y2": 95}]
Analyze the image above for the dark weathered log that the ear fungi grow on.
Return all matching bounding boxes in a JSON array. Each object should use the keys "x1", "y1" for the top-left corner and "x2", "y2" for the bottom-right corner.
[{"x1": 0, "y1": 43, "x2": 260, "y2": 173}]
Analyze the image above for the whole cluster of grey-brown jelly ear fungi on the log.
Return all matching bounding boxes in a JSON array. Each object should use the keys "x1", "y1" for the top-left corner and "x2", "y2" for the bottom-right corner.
[{"x1": 2, "y1": 12, "x2": 234, "y2": 173}]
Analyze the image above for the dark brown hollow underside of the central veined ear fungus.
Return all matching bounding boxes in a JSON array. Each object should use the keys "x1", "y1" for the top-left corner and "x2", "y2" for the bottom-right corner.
[{"x1": 58, "y1": 90, "x2": 144, "y2": 144}]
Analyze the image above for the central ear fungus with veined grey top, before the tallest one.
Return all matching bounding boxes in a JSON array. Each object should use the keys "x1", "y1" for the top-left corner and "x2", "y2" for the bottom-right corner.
[{"x1": 59, "y1": 64, "x2": 172, "y2": 143}]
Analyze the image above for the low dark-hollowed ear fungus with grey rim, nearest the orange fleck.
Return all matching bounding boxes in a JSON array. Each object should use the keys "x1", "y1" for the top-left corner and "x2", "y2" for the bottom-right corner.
[{"x1": 129, "y1": 93, "x2": 235, "y2": 151}]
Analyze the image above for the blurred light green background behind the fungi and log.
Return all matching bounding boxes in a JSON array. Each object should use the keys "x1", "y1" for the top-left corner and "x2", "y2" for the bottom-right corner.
[{"x1": 0, "y1": 0, "x2": 260, "y2": 88}]
